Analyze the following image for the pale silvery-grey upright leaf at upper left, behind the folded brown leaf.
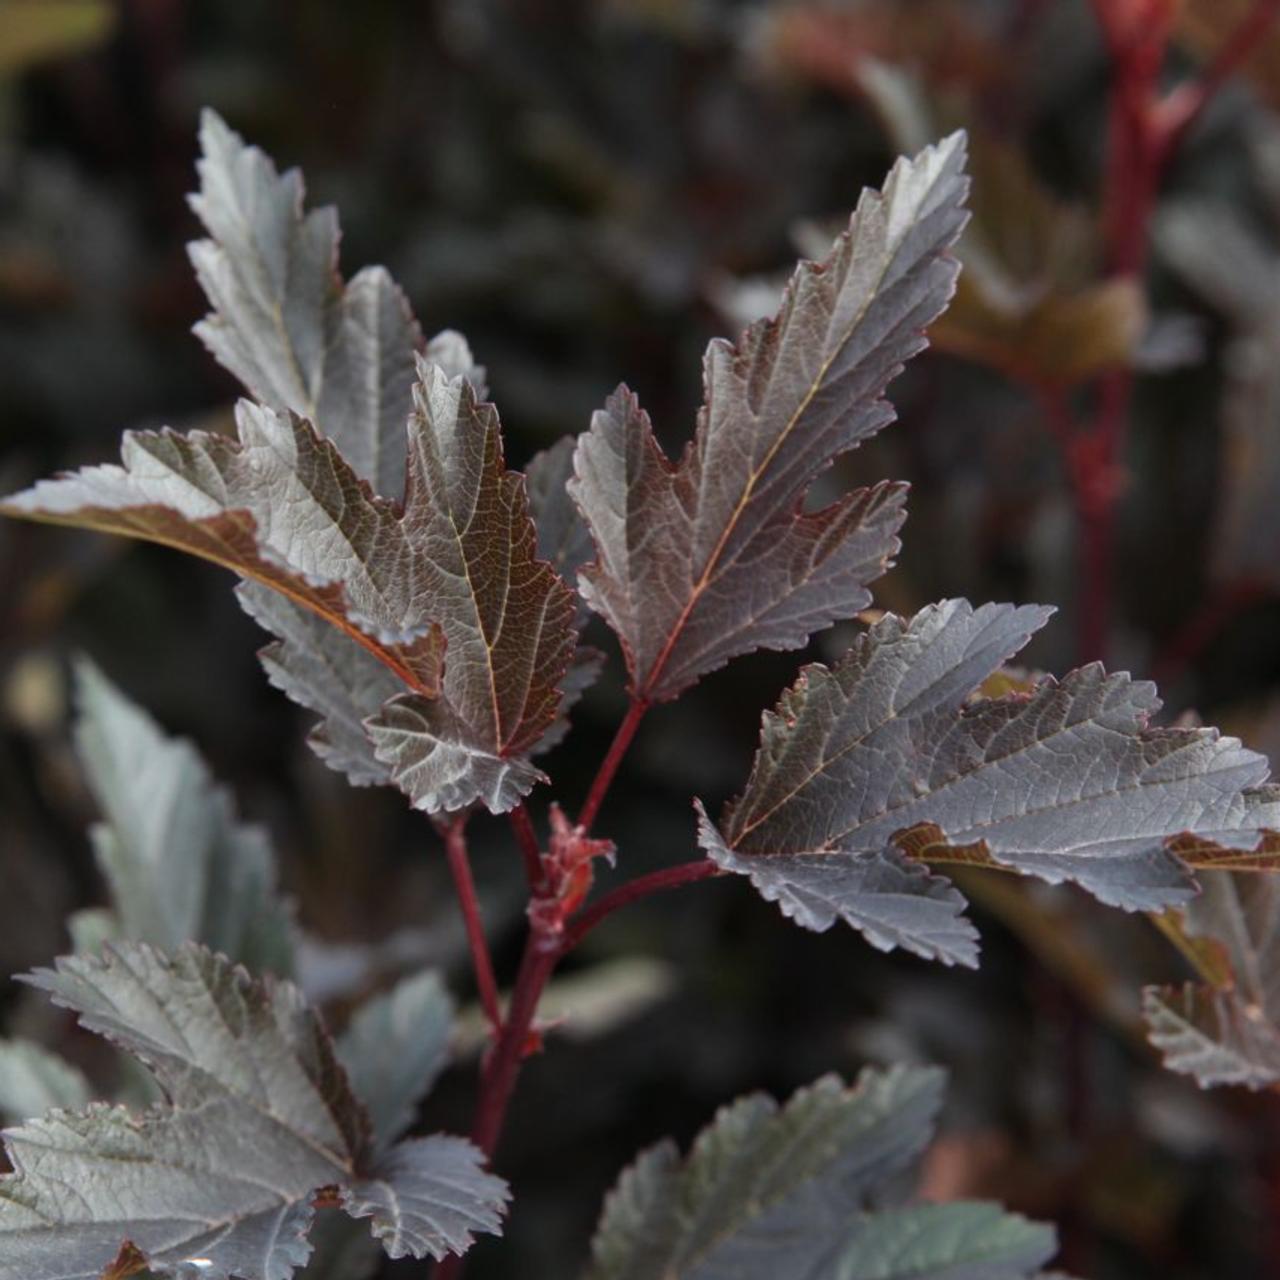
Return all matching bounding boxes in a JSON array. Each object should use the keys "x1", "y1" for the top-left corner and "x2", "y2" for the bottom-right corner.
[{"x1": 189, "y1": 110, "x2": 419, "y2": 498}]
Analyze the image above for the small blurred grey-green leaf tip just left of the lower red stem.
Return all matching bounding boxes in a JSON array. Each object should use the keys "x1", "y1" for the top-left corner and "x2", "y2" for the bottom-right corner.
[{"x1": 337, "y1": 972, "x2": 453, "y2": 1152}]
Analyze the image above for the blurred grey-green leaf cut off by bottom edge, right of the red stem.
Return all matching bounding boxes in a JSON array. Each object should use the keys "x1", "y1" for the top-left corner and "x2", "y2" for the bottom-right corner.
[{"x1": 586, "y1": 1068, "x2": 1055, "y2": 1280}]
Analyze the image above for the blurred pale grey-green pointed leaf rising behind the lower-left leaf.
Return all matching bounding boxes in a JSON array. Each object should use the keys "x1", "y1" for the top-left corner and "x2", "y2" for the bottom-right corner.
[{"x1": 76, "y1": 660, "x2": 293, "y2": 974}]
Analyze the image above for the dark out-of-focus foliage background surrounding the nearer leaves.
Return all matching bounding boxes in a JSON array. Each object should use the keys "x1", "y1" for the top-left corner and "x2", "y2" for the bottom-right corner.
[{"x1": 0, "y1": 0, "x2": 1280, "y2": 1280}]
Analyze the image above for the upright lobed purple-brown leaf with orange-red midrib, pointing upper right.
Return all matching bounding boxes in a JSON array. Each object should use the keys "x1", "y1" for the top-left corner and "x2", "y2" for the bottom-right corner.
[{"x1": 571, "y1": 134, "x2": 966, "y2": 700}]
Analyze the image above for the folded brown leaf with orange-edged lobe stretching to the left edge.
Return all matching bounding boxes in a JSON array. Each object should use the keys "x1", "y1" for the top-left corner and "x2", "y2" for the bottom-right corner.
[{"x1": 0, "y1": 360, "x2": 576, "y2": 813}]
